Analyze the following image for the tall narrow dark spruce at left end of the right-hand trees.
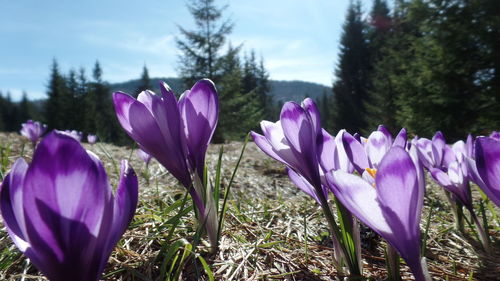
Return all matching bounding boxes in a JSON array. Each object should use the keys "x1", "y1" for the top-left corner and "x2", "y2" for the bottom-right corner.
[{"x1": 333, "y1": 1, "x2": 369, "y2": 133}]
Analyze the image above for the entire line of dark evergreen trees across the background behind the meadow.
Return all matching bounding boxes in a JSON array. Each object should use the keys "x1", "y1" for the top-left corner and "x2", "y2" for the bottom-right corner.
[{"x1": 0, "y1": 0, "x2": 500, "y2": 144}]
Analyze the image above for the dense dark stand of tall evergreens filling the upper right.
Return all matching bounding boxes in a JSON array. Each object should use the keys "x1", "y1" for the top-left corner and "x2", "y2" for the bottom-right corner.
[{"x1": 322, "y1": 0, "x2": 500, "y2": 140}]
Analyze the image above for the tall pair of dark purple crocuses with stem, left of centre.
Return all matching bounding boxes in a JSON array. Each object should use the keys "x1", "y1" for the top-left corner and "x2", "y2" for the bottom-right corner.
[{"x1": 113, "y1": 79, "x2": 219, "y2": 249}]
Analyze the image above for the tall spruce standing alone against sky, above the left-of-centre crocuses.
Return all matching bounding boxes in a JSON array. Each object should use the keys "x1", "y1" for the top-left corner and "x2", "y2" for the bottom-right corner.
[{"x1": 177, "y1": 0, "x2": 233, "y2": 87}]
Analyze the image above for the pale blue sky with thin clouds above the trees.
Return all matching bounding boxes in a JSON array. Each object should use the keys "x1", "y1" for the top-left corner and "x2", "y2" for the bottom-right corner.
[{"x1": 0, "y1": 0, "x2": 371, "y2": 100}]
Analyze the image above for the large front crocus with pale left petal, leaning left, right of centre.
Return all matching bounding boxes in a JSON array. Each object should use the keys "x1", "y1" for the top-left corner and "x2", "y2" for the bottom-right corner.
[{"x1": 326, "y1": 146, "x2": 430, "y2": 280}]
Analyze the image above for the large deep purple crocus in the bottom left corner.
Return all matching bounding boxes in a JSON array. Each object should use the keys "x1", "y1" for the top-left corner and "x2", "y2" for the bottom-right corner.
[{"x1": 0, "y1": 131, "x2": 138, "y2": 281}]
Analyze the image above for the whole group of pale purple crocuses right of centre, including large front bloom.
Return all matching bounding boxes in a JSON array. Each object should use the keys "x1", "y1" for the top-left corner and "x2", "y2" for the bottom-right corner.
[{"x1": 252, "y1": 99, "x2": 430, "y2": 280}]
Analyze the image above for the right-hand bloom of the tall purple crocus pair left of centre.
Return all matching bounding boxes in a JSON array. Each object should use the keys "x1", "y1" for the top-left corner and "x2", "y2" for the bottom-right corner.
[{"x1": 178, "y1": 79, "x2": 219, "y2": 175}]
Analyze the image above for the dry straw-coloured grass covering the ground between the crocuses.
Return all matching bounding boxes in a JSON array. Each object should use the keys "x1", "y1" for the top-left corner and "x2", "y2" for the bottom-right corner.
[{"x1": 0, "y1": 134, "x2": 500, "y2": 281}]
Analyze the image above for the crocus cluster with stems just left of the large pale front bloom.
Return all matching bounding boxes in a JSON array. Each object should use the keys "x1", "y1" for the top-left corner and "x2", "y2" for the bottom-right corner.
[{"x1": 251, "y1": 98, "x2": 361, "y2": 275}]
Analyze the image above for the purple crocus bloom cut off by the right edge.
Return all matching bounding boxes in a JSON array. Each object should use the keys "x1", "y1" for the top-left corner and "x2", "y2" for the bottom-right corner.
[{"x1": 467, "y1": 137, "x2": 500, "y2": 207}]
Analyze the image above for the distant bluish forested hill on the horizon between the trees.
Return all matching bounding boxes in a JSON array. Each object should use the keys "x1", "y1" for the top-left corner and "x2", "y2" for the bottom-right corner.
[{"x1": 110, "y1": 78, "x2": 331, "y2": 102}]
